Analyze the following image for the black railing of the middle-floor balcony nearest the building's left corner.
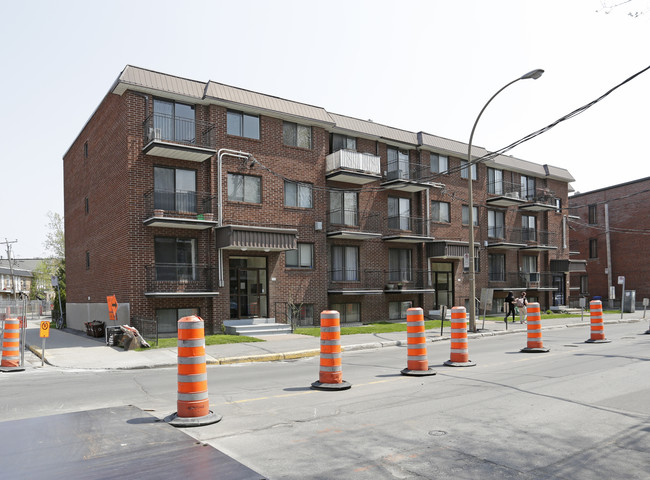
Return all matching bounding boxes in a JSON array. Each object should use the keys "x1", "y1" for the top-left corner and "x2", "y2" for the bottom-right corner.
[{"x1": 144, "y1": 189, "x2": 218, "y2": 218}]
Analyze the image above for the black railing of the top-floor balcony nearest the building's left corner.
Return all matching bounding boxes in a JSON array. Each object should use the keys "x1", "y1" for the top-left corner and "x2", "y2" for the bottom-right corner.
[{"x1": 144, "y1": 113, "x2": 216, "y2": 150}]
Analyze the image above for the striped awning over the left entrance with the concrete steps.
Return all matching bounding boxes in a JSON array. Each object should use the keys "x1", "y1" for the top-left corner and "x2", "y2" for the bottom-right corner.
[{"x1": 215, "y1": 225, "x2": 298, "y2": 252}]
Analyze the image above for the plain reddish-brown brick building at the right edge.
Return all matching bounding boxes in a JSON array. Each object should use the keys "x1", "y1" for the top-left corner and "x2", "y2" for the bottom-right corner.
[{"x1": 569, "y1": 177, "x2": 650, "y2": 306}]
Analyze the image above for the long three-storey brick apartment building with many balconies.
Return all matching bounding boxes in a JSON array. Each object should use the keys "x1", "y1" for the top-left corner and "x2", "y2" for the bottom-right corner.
[{"x1": 64, "y1": 66, "x2": 573, "y2": 332}]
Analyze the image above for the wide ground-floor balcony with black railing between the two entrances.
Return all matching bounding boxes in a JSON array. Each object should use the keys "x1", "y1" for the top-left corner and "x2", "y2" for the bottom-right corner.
[{"x1": 327, "y1": 269, "x2": 435, "y2": 295}]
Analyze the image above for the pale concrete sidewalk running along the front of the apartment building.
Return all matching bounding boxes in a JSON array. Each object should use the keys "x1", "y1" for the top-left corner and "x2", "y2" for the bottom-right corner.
[{"x1": 16, "y1": 312, "x2": 646, "y2": 370}]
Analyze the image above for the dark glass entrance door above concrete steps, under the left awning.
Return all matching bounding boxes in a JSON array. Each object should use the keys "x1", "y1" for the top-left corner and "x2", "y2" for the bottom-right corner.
[{"x1": 230, "y1": 257, "x2": 268, "y2": 318}]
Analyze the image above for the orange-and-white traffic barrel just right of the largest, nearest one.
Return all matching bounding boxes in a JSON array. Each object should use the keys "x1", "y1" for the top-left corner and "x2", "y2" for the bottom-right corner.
[{"x1": 311, "y1": 310, "x2": 352, "y2": 390}]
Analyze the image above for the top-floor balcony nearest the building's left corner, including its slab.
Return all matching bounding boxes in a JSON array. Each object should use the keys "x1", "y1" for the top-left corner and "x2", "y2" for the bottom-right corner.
[{"x1": 142, "y1": 113, "x2": 217, "y2": 162}]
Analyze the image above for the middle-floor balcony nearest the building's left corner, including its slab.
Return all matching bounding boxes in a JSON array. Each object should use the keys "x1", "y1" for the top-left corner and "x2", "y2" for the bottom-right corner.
[{"x1": 144, "y1": 190, "x2": 217, "y2": 230}]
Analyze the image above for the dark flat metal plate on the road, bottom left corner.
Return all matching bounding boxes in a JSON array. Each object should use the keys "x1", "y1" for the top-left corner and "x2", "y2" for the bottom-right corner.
[{"x1": 0, "y1": 406, "x2": 264, "y2": 480}]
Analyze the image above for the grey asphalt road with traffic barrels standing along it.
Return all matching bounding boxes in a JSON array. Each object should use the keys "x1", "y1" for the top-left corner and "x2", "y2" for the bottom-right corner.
[{"x1": 0, "y1": 323, "x2": 650, "y2": 480}]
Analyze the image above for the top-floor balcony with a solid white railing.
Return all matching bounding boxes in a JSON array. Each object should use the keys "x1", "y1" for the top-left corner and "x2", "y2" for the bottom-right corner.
[{"x1": 325, "y1": 150, "x2": 381, "y2": 185}]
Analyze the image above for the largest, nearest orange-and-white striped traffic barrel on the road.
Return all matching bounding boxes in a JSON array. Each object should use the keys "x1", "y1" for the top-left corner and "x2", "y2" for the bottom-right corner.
[{"x1": 165, "y1": 315, "x2": 221, "y2": 427}]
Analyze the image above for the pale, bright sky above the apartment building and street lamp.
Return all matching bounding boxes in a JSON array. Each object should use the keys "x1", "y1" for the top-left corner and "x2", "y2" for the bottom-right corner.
[{"x1": 0, "y1": 0, "x2": 650, "y2": 258}]
